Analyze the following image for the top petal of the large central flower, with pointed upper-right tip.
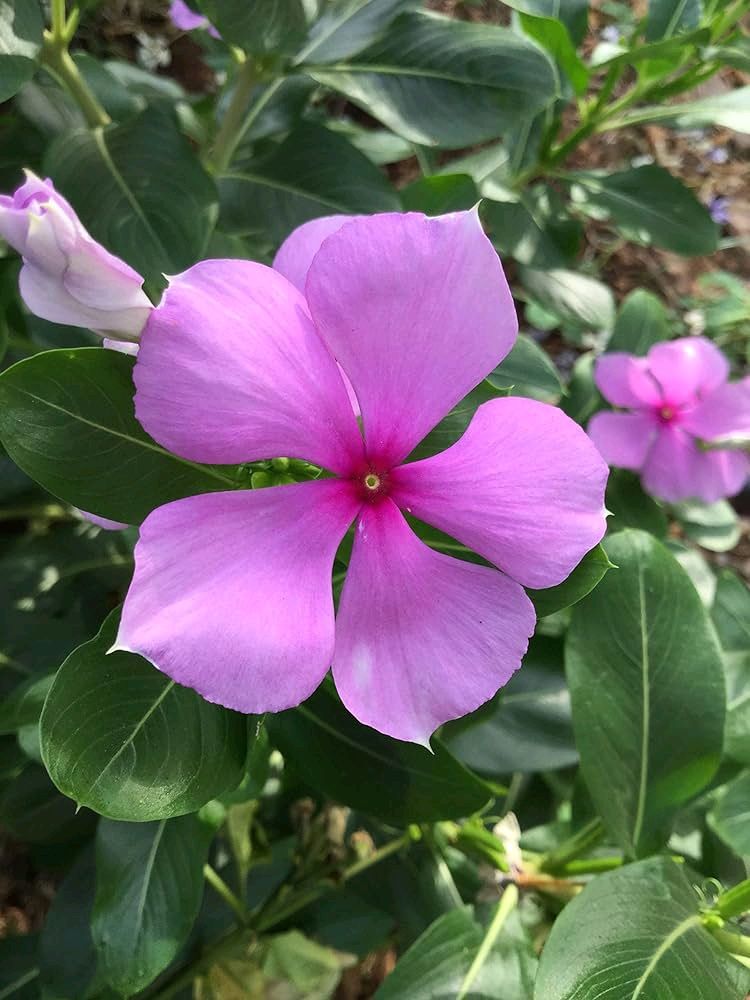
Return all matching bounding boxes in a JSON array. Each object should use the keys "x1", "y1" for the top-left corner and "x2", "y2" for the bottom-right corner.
[{"x1": 306, "y1": 211, "x2": 518, "y2": 466}]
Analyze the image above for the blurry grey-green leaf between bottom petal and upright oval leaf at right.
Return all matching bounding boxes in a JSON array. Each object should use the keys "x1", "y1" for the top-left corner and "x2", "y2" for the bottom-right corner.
[{"x1": 445, "y1": 636, "x2": 578, "y2": 779}]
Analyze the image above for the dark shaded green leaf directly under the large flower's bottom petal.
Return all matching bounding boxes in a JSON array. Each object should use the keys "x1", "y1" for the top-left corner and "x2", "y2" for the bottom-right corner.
[{"x1": 268, "y1": 685, "x2": 491, "y2": 826}]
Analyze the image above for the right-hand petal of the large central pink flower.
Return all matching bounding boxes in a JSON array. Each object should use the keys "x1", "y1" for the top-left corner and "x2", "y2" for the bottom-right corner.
[{"x1": 391, "y1": 396, "x2": 608, "y2": 588}]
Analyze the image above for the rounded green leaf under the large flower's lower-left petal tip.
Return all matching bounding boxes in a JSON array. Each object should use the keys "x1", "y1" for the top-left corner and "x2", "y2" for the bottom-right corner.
[{"x1": 41, "y1": 612, "x2": 247, "y2": 821}]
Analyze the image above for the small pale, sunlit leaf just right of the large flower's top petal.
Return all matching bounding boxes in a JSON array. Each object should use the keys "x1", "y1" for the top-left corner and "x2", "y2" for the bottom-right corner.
[{"x1": 520, "y1": 267, "x2": 615, "y2": 331}]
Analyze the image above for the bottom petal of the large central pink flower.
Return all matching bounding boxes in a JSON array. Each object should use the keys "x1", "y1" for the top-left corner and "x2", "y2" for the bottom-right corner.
[{"x1": 333, "y1": 498, "x2": 535, "y2": 746}]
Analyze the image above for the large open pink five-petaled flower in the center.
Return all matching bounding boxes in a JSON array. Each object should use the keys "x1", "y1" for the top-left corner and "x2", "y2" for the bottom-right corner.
[{"x1": 115, "y1": 212, "x2": 607, "y2": 744}]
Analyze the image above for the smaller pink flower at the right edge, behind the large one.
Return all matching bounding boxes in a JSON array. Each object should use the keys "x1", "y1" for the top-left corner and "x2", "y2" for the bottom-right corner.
[{"x1": 588, "y1": 337, "x2": 750, "y2": 503}]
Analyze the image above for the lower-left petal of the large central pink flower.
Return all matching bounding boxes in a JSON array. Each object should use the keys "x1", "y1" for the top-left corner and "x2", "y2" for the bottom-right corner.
[{"x1": 114, "y1": 479, "x2": 358, "y2": 713}]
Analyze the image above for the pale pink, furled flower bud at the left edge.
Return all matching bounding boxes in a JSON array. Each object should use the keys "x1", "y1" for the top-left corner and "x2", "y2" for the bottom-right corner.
[{"x1": 0, "y1": 170, "x2": 152, "y2": 340}]
